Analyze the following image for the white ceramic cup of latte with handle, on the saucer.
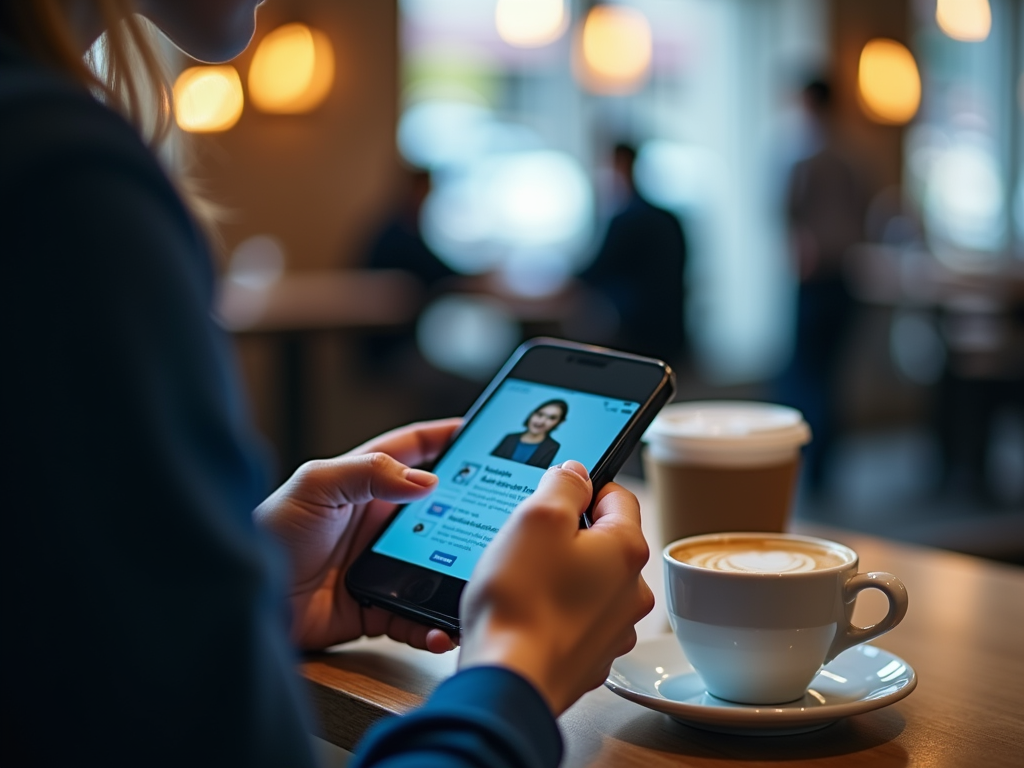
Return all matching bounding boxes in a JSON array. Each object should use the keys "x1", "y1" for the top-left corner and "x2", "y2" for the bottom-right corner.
[{"x1": 663, "y1": 532, "x2": 907, "y2": 705}]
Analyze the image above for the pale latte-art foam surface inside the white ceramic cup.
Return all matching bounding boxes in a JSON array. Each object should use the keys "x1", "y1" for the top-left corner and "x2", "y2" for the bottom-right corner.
[{"x1": 670, "y1": 539, "x2": 850, "y2": 573}]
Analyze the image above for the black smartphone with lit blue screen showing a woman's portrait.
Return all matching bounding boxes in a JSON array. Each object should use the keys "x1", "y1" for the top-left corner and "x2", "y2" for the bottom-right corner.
[{"x1": 345, "y1": 339, "x2": 675, "y2": 634}]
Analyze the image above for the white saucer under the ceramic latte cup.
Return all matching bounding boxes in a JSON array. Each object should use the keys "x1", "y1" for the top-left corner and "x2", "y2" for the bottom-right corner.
[{"x1": 604, "y1": 635, "x2": 918, "y2": 735}]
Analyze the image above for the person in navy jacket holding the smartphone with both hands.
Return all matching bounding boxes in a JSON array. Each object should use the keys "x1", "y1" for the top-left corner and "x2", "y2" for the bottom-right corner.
[{"x1": 0, "y1": 0, "x2": 653, "y2": 766}]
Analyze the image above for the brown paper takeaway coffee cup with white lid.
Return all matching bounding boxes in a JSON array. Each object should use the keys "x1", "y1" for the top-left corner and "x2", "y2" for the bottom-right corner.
[{"x1": 643, "y1": 400, "x2": 811, "y2": 542}]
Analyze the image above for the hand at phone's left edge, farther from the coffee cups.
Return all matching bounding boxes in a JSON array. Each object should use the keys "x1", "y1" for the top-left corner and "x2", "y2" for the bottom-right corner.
[{"x1": 254, "y1": 419, "x2": 460, "y2": 653}]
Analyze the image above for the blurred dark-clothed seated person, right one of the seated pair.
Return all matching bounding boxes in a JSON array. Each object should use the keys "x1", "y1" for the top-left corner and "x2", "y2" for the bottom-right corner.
[{"x1": 580, "y1": 143, "x2": 688, "y2": 369}]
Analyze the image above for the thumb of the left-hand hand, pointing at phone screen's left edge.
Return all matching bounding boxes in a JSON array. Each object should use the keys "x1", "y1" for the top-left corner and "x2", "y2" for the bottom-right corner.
[{"x1": 300, "y1": 453, "x2": 437, "y2": 507}]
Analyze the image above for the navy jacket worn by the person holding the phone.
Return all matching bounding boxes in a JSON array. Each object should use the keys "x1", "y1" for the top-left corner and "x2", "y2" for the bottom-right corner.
[{"x1": 0, "y1": 37, "x2": 561, "y2": 767}]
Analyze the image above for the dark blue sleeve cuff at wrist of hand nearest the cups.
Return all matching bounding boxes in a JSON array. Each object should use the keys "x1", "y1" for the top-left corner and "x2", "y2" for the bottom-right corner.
[{"x1": 352, "y1": 667, "x2": 562, "y2": 768}]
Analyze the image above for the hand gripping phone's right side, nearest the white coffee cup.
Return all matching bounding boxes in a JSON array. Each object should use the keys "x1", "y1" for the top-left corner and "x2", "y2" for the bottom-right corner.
[{"x1": 460, "y1": 461, "x2": 654, "y2": 716}]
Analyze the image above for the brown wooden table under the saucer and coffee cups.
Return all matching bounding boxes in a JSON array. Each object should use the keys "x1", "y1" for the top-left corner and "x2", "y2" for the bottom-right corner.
[{"x1": 302, "y1": 487, "x2": 1024, "y2": 768}]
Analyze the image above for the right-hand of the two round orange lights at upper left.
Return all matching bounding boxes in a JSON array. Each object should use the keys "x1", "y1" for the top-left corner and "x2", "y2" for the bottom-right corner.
[{"x1": 249, "y1": 24, "x2": 334, "y2": 115}]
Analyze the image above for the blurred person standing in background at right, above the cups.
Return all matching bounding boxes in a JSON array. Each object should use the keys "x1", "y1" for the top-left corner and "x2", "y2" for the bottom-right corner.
[{"x1": 776, "y1": 80, "x2": 867, "y2": 494}]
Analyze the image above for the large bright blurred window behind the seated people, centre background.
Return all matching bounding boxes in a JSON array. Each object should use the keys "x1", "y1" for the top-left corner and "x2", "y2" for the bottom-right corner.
[{"x1": 398, "y1": 0, "x2": 828, "y2": 381}]
